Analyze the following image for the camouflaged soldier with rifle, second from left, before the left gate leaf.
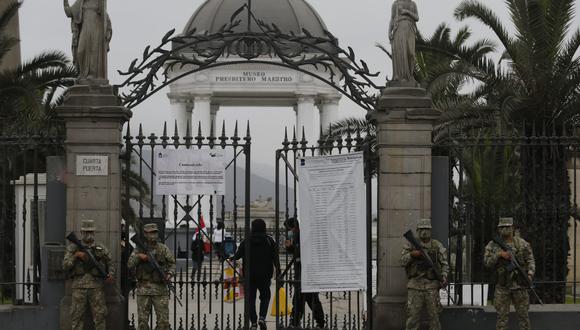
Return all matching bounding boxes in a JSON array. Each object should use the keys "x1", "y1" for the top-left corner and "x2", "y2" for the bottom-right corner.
[{"x1": 128, "y1": 223, "x2": 175, "y2": 330}]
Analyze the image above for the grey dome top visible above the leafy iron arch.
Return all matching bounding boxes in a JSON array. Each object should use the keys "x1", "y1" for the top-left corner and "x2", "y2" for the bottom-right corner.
[{"x1": 183, "y1": 0, "x2": 326, "y2": 36}]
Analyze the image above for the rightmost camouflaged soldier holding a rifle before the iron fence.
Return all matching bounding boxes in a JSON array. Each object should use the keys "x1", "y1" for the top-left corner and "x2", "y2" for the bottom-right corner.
[{"x1": 484, "y1": 218, "x2": 536, "y2": 330}]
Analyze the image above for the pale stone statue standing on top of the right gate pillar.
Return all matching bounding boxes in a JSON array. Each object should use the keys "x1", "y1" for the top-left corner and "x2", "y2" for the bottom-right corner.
[{"x1": 389, "y1": 0, "x2": 419, "y2": 83}]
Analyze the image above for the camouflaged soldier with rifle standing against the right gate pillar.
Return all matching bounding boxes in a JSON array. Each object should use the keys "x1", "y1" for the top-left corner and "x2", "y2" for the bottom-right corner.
[{"x1": 401, "y1": 219, "x2": 449, "y2": 330}]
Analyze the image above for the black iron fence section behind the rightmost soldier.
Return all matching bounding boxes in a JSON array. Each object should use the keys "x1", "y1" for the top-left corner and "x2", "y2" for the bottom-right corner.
[{"x1": 434, "y1": 128, "x2": 580, "y2": 305}]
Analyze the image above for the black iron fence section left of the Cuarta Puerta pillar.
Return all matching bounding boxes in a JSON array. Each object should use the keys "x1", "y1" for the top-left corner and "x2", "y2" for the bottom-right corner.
[{"x1": 0, "y1": 135, "x2": 63, "y2": 305}]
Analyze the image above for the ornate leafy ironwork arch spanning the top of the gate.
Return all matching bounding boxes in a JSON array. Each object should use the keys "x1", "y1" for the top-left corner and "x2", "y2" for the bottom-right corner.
[{"x1": 117, "y1": 5, "x2": 383, "y2": 111}]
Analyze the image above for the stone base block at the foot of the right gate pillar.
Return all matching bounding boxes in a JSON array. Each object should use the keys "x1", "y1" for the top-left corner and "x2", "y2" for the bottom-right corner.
[{"x1": 373, "y1": 296, "x2": 407, "y2": 330}]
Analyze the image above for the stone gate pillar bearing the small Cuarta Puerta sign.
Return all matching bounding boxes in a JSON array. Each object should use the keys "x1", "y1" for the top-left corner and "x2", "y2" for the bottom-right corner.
[{"x1": 57, "y1": 81, "x2": 131, "y2": 330}]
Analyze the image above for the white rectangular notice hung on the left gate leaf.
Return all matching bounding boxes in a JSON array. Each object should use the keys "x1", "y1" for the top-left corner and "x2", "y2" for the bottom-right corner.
[{"x1": 155, "y1": 149, "x2": 226, "y2": 195}]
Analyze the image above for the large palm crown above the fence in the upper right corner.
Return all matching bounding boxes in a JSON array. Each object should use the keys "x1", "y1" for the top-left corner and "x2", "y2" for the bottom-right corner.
[{"x1": 455, "y1": 0, "x2": 580, "y2": 126}]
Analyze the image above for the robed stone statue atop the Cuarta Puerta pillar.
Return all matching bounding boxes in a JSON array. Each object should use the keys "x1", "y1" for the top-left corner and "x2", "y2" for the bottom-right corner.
[{"x1": 64, "y1": 0, "x2": 113, "y2": 80}]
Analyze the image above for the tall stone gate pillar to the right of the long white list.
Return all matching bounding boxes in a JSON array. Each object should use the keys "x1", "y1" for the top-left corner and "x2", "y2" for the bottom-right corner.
[{"x1": 369, "y1": 87, "x2": 439, "y2": 330}]
